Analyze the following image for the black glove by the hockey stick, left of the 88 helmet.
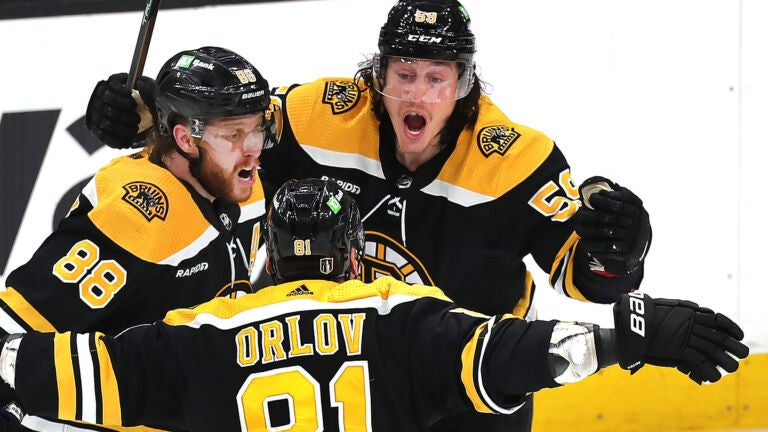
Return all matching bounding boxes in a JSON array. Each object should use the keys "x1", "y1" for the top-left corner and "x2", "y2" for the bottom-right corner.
[{"x1": 85, "y1": 73, "x2": 155, "y2": 149}]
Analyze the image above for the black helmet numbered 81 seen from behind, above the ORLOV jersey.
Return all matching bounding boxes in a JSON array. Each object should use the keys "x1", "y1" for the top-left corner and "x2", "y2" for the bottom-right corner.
[{"x1": 264, "y1": 178, "x2": 365, "y2": 283}]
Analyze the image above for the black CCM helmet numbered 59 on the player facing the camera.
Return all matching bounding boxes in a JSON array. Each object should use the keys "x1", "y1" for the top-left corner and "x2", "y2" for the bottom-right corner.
[{"x1": 379, "y1": 0, "x2": 475, "y2": 63}]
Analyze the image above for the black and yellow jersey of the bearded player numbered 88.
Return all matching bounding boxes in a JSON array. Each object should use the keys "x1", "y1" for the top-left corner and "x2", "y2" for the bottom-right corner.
[{"x1": 0, "y1": 152, "x2": 265, "y2": 334}]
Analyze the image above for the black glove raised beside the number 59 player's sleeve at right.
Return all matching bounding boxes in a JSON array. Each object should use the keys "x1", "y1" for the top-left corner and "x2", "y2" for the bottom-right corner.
[{"x1": 574, "y1": 177, "x2": 651, "y2": 276}]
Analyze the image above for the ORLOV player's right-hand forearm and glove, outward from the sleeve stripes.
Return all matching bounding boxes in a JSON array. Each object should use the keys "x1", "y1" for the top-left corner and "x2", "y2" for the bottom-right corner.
[{"x1": 474, "y1": 293, "x2": 749, "y2": 405}]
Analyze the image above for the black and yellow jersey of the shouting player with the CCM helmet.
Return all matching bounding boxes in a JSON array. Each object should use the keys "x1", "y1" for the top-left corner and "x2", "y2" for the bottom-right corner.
[{"x1": 261, "y1": 78, "x2": 642, "y2": 318}]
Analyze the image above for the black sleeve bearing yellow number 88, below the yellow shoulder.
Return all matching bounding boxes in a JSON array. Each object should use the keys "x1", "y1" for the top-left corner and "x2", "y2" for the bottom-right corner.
[{"x1": 0, "y1": 195, "x2": 146, "y2": 333}]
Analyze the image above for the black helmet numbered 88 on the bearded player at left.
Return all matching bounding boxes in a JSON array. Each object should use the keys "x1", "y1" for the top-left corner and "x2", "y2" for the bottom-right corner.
[{"x1": 155, "y1": 46, "x2": 274, "y2": 140}]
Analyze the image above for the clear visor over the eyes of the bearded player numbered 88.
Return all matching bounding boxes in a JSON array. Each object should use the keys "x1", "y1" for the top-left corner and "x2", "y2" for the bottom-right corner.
[{"x1": 192, "y1": 116, "x2": 275, "y2": 152}]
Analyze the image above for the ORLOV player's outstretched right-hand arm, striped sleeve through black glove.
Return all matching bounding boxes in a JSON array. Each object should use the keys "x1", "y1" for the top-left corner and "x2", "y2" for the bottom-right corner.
[{"x1": 403, "y1": 293, "x2": 749, "y2": 419}]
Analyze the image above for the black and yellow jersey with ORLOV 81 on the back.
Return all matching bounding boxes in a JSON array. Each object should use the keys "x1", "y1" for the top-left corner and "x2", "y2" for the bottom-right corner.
[{"x1": 10, "y1": 277, "x2": 557, "y2": 432}]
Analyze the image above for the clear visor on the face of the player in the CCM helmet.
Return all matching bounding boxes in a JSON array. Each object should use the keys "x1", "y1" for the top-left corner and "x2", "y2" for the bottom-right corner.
[{"x1": 373, "y1": 54, "x2": 475, "y2": 103}]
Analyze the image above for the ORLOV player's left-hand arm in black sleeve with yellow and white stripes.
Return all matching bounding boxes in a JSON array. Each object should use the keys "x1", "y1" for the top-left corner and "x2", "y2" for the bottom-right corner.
[{"x1": 0, "y1": 325, "x2": 189, "y2": 430}]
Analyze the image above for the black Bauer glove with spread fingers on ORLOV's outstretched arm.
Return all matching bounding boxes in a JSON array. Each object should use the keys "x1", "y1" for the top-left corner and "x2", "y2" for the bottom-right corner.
[{"x1": 613, "y1": 292, "x2": 749, "y2": 384}]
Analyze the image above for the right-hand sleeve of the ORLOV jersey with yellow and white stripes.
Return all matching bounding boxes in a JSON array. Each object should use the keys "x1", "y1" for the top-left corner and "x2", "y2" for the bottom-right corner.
[{"x1": 388, "y1": 286, "x2": 558, "y2": 424}]
